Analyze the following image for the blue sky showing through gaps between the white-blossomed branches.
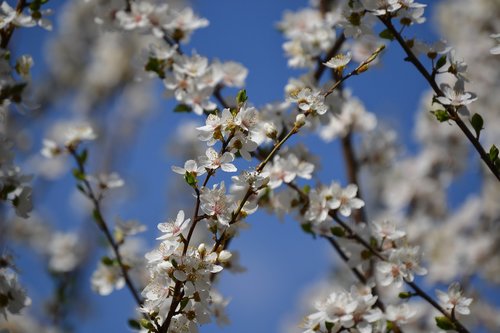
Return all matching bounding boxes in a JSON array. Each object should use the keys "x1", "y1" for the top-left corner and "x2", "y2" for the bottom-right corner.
[{"x1": 0, "y1": 0, "x2": 500, "y2": 333}]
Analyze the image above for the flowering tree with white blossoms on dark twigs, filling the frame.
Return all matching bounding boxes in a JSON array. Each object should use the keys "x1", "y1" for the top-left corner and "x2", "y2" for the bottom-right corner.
[{"x1": 0, "y1": 0, "x2": 500, "y2": 333}]
